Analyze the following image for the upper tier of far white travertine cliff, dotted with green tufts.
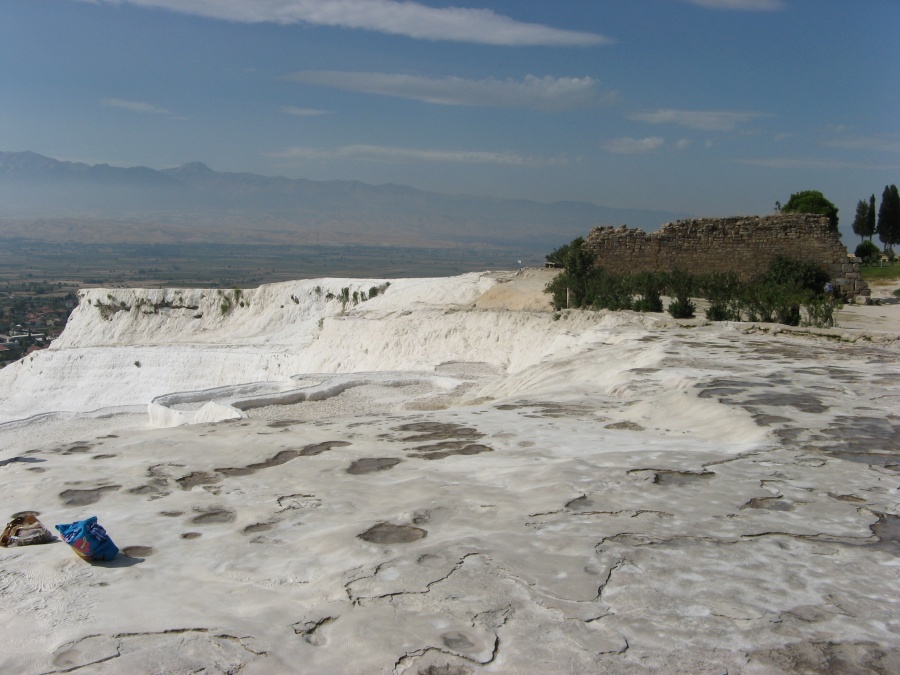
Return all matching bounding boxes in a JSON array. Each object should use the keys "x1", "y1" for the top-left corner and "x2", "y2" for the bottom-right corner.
[{"x1": 53, "y1": 273, "x2": 497, "y2": 349}]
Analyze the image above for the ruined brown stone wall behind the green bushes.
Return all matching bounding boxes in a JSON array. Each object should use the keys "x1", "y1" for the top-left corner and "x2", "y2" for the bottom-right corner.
[{"x1": 585, "y1": 214, "x2": 869, "y2": 297}]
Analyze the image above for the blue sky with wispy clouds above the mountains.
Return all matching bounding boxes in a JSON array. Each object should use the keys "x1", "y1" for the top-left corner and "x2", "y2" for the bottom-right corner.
[{"x1": 0, "y1": 0, "x2": 900, "y2": 234}]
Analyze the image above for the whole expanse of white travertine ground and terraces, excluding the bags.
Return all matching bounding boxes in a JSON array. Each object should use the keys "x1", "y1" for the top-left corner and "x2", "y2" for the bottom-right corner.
[{"x1": 0, "y1": 270, "x2": 900, "y2": 674}]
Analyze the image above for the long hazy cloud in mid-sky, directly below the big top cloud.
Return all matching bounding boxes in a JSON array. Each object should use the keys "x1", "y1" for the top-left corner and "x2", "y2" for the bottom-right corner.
[{"x1": 287, "y1": 70, "x2": 616, "y2": 110}]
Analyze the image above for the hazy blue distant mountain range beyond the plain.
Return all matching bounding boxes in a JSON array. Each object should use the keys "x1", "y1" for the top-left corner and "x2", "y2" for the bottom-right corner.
[{"x1": 0, "y1": 152, "x2": 686, "y2": 247}]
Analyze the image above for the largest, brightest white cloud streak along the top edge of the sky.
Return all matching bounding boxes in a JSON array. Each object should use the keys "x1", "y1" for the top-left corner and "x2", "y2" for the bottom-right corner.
[{"x1": 81, "y1": 0, "x2": 612, "y2": 46}]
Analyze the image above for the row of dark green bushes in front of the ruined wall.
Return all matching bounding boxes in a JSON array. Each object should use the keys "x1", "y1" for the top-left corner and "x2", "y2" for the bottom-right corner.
[{"x1": 545, "y1": 238, "x2": 842, "y2": 327}]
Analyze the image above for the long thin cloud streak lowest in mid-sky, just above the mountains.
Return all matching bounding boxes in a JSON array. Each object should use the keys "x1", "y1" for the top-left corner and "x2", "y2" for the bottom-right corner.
[{"x1": 265, "y1": 145, "x2": 569, "y2": 167}]
